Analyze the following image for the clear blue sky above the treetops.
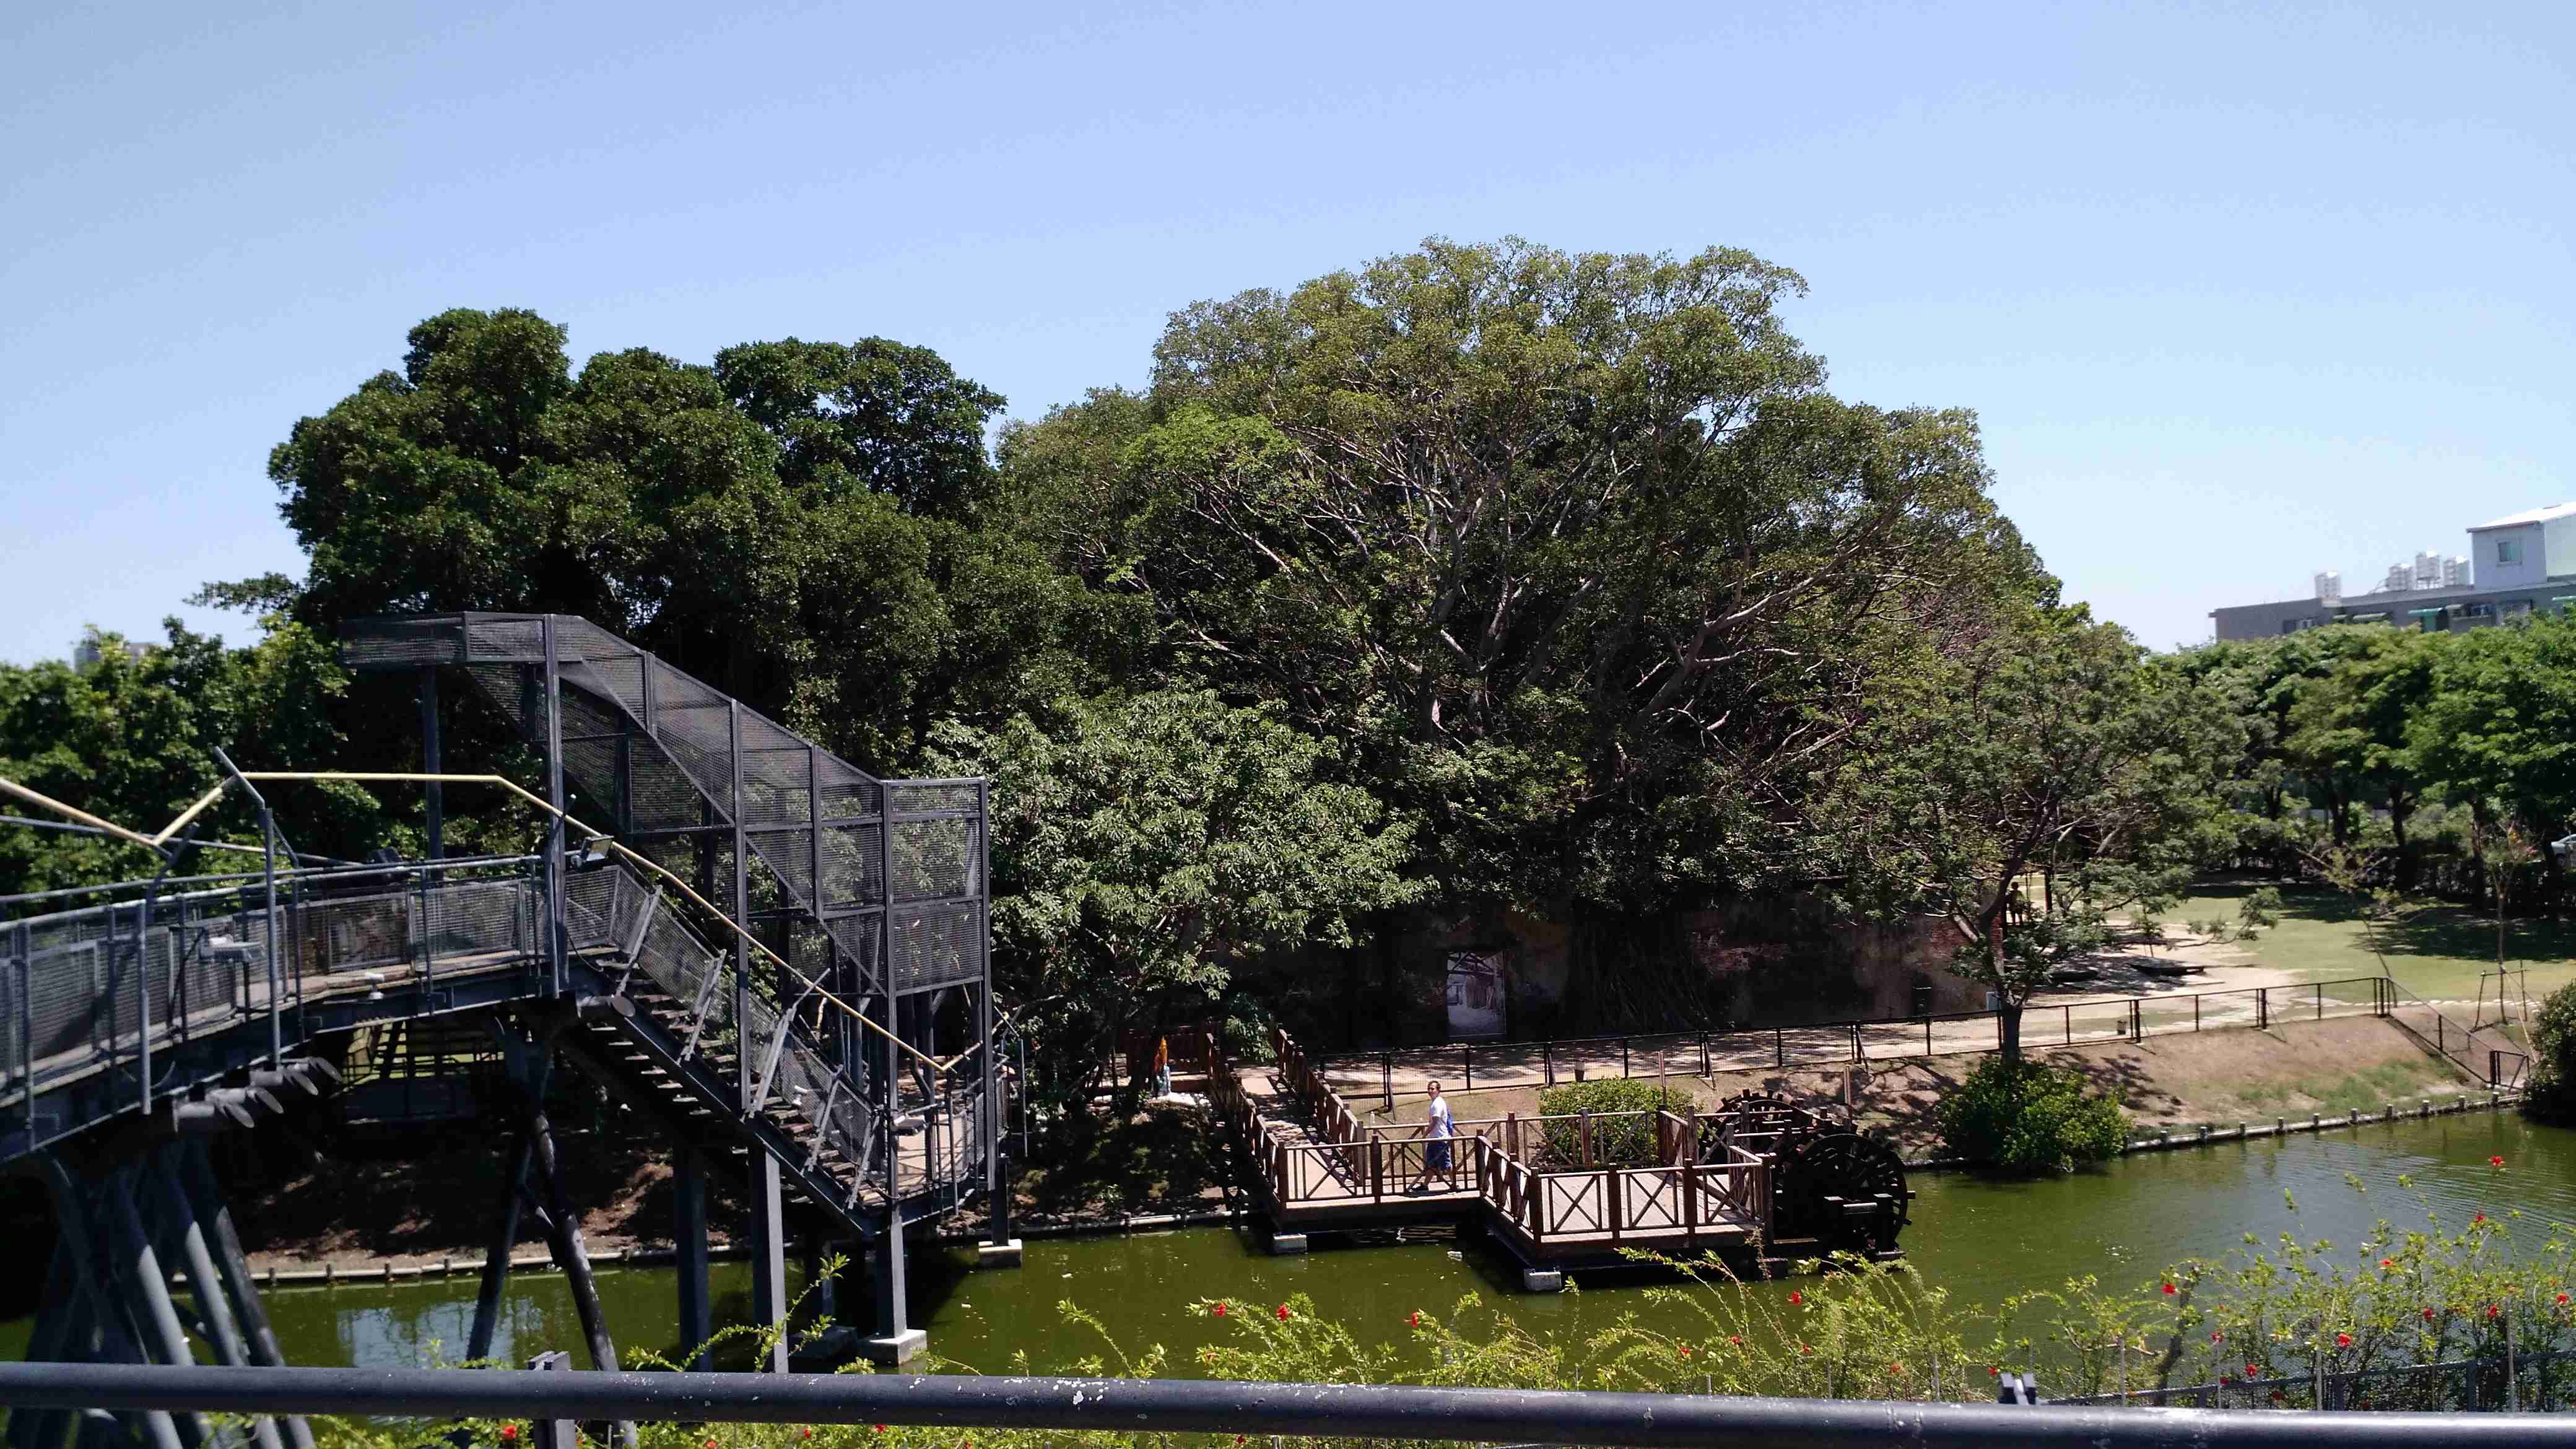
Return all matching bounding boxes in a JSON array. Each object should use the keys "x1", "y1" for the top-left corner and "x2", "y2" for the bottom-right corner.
[{"x1": 0, "y1": 0, "x2": 2576, "y2": 660}]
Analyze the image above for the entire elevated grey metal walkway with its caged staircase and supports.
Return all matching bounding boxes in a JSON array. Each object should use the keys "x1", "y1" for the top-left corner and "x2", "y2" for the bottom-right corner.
[{"x1": 0, "y1": 603, "x2": 1010, "y2": 1392}]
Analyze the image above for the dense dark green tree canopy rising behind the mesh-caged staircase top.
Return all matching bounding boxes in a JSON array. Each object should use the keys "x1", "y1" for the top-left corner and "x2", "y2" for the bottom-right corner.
[{"x1": 251, "y1": 310, "x2": 1131, "y2": 768}]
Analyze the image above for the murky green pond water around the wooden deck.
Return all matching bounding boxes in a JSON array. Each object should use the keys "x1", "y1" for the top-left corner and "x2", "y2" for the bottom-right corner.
[{"x1": 0, "y1": 1112, "x2": 2576, "y2": 1374}]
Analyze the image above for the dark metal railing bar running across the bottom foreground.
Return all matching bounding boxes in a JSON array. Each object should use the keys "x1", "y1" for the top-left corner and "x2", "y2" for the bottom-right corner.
[{"x1": 0, "y1": 1364, "x2": 2576, "y2": 1449}]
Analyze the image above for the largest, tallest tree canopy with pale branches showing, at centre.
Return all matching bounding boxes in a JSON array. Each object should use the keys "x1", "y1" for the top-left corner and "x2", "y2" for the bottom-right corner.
[{"x1": 1002, "y1": 240, "x2": 2053, "y2": 908}]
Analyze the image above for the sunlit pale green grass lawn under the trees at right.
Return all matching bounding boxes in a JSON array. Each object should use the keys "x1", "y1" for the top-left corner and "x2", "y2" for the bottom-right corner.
[{"x1": 2164, "y1": 866, "x2": 2576, "y2": 1006}]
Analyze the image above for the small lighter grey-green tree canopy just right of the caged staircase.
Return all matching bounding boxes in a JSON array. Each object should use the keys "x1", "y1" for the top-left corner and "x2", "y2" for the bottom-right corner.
[{"x1": 943, "y1": 691, "x2": 1422, "y2": 1124}]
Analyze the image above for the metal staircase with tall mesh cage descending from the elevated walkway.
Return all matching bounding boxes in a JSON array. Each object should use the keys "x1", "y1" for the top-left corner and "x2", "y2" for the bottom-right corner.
[{"x1": 342, "y1": 614, "x2": 999, "y2": 1235}]
